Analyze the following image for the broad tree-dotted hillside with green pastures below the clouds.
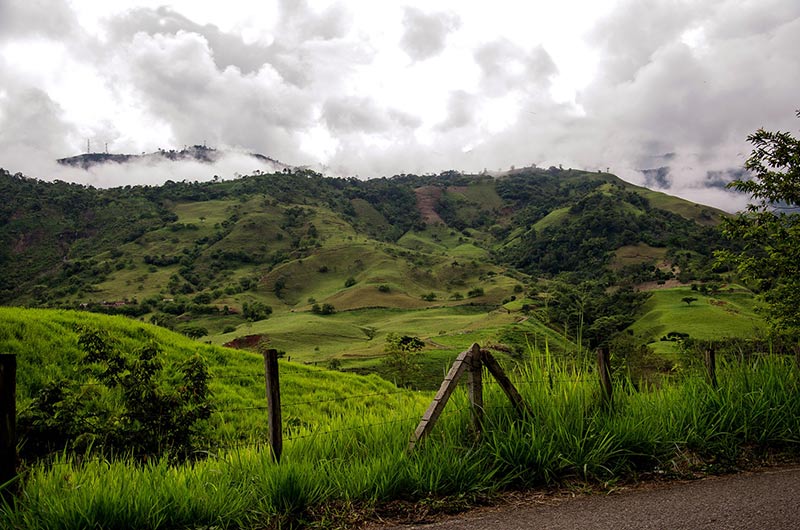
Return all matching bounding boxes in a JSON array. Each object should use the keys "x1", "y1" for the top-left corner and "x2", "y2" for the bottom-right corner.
[{"x1": 0, "y1": 163, "x2": 744, "y2": 387}]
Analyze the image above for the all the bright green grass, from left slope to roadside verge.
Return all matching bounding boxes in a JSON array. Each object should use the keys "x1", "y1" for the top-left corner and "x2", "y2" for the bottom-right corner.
[{"x1": 0, "y1": 309, "x2": 800, "y2": 530}]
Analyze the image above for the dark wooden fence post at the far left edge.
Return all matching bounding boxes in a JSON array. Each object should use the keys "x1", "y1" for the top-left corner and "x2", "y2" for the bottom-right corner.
[{"x1": 0, "y1": 355, "x2": 17, "y2": 500}]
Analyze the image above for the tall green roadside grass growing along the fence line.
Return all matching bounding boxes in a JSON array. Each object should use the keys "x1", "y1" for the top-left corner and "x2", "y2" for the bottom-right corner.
[{"x1": 0, "y1": 342, "x2": 800, "y2": 529}]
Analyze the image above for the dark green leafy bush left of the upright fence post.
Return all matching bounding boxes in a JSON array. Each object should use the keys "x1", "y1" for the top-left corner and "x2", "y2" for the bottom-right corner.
[{"x1": 19, "y1": 327, "x2": 211, "y2": 457}]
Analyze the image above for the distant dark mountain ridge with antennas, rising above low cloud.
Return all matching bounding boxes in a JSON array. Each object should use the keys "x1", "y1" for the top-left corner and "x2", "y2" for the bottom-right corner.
[{"x1": 57, "y1": 145, "x2": 291, "y2": 171}]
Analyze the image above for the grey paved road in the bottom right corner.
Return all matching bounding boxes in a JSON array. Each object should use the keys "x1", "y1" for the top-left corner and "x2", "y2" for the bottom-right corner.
[{"x1": 384, "y1": 466, "x2": 800, "y2": 530}]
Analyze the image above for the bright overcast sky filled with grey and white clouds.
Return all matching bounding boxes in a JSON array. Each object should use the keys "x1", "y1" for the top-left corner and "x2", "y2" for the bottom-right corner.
[{"x1": 0, "y1": 0, "x2": 800, "y2": 211}]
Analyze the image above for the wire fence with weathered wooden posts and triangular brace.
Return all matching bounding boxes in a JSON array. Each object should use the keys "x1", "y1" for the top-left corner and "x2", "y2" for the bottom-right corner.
[{"x1": 0, "y1": 344, "x2": 717, "y2": 490}]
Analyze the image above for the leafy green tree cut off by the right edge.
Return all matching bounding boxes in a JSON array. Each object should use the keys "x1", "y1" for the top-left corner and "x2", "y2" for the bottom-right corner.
[{"x1": 717, "y1": 111, "x2": 800, "y2": 338}]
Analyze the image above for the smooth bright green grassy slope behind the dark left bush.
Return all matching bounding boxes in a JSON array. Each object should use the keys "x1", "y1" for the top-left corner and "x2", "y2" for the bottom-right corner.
[{"x1": 0, "y1": 308, "x2": 432, "y2": 443}]
